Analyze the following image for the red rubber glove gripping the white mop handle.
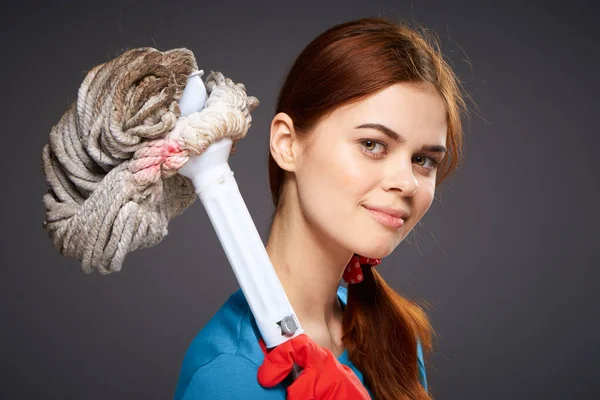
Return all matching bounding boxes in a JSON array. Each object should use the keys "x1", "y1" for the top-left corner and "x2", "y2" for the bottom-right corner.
[{"x1": 258, "y1": 333, "x2": 371, "y2": 400}]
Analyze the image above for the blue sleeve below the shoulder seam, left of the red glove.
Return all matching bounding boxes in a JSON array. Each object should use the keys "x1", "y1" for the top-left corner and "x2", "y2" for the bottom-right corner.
[{"x1": 183, "y1": 354, "x2": 285, "y2": 400}]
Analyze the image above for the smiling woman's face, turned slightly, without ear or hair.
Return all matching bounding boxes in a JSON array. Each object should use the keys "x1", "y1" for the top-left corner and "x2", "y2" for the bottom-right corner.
[{"x1": 294, "y1": 83, "x2": 447, "y2": 258}]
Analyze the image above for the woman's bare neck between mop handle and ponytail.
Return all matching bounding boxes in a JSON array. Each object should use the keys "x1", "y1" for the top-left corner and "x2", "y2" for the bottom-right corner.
[{"x1": 266, "y1": 203, "x2": 352, "y2": 351}]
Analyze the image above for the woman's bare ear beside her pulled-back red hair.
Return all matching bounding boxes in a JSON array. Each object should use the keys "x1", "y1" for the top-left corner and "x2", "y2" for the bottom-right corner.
[{"x1": 269, "y1": 112, "x2": 298, "y2": 172}]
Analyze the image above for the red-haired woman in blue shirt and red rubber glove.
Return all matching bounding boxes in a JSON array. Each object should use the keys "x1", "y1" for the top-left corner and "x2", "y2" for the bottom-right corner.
[{"x1": 175, "y1": 18, "x2": 465, "y2": 400}]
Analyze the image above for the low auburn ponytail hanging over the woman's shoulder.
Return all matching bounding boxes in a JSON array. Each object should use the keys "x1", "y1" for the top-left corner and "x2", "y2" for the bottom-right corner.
[{"x1": 342, "y1": 267, "x2": 432, "y2": 400}]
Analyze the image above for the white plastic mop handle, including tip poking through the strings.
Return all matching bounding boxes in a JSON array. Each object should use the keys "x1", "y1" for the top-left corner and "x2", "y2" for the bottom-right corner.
[{"x1": 179, "y1": 71, "x2": 303, "y2": 348}]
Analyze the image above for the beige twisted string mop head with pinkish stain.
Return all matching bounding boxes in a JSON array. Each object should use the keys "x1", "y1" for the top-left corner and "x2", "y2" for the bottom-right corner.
[{"x1": 42, "y1": 48, "x2": 258, "y2": 274}]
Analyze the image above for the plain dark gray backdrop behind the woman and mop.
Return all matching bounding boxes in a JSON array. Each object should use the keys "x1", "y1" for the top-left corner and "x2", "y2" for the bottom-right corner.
[{"x1": 0, "y1": 0, "x2": 600, "y2": 400}]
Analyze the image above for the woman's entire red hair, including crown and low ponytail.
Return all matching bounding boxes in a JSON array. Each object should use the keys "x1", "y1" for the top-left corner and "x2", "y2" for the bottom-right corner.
[{"x1": 269, "y1": 18, "x2": 466, "y2": 400}]
